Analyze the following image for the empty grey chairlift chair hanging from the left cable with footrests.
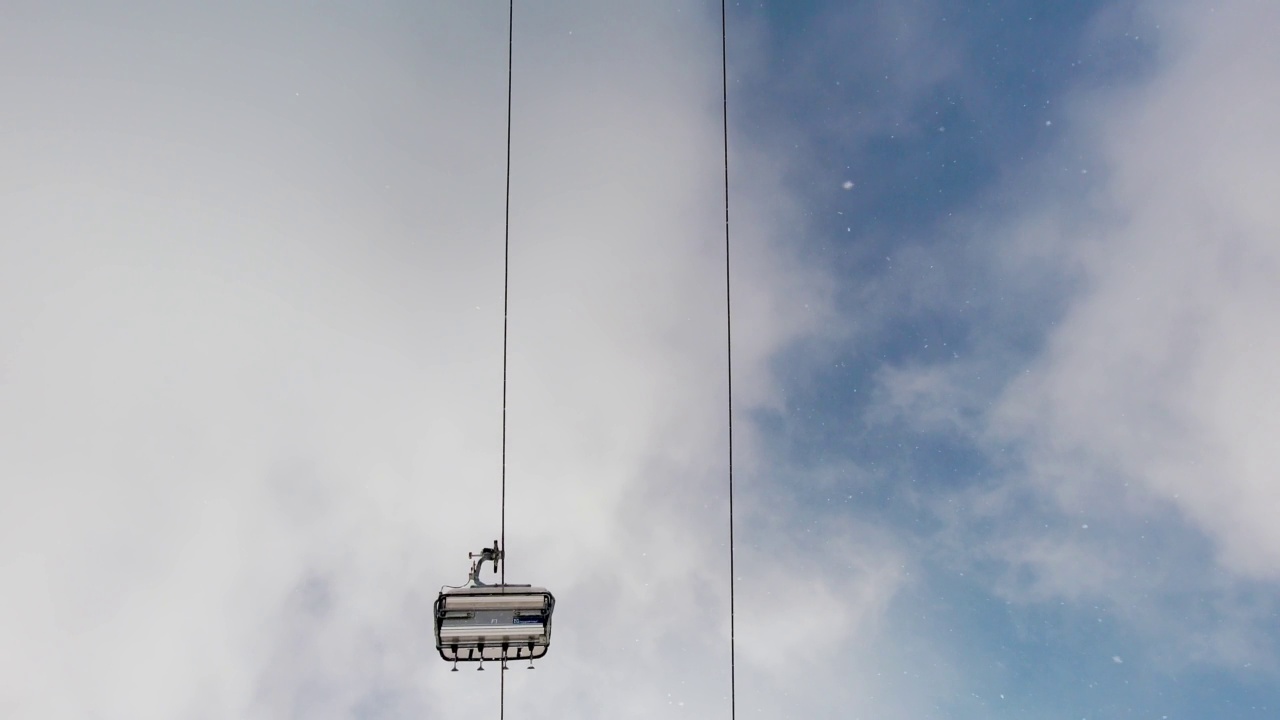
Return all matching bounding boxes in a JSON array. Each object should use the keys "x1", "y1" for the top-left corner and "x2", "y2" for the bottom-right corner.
[{"x1": 435, "y1": 541, "x2": 556, "y2": 671}]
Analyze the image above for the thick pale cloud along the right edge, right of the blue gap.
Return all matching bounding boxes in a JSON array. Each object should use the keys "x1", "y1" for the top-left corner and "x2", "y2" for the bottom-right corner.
[{"x1": 1002, "y1": 1, "x2": 1280, "y2": 579}]
